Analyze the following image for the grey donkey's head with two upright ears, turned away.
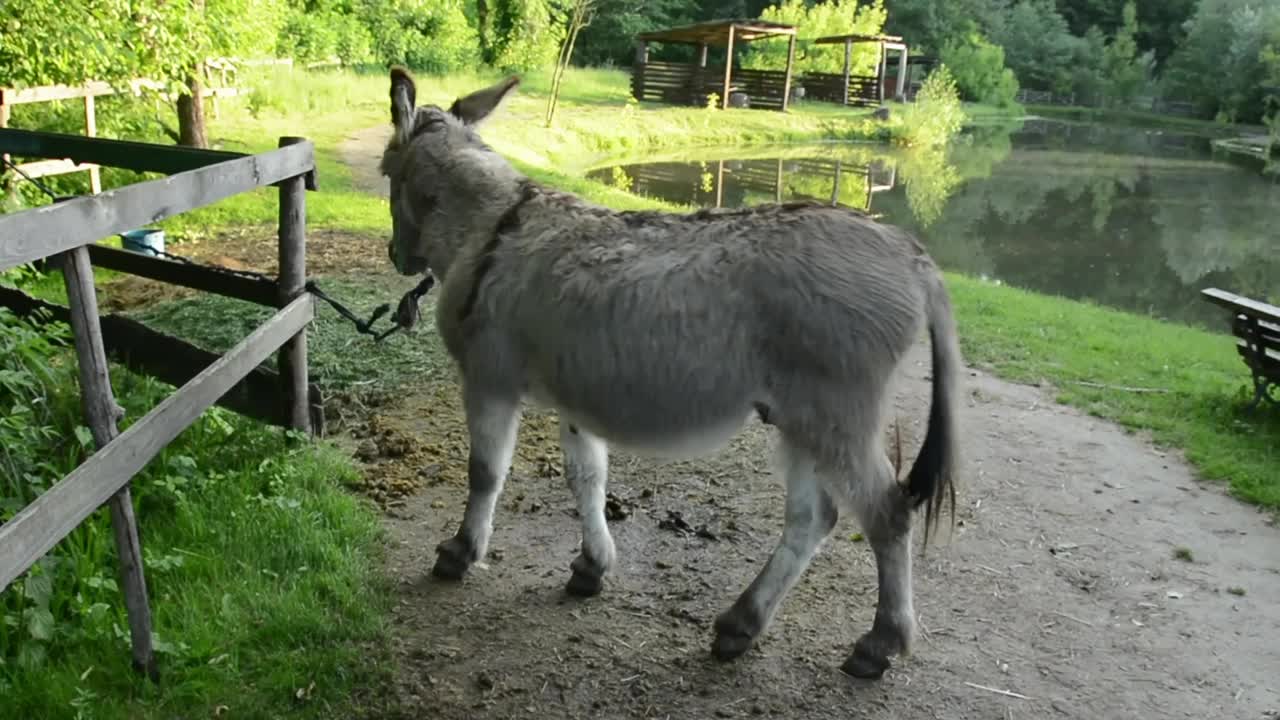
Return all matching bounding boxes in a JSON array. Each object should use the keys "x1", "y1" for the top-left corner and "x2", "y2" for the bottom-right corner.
[{"x1": 381, "y1": 67, "x2": 520, "y2": 279}]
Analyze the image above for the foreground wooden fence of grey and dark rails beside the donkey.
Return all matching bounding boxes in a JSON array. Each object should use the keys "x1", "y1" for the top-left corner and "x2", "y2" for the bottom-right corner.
[{"x1": 0, "y1": 129, "x2": 315, "y2": 678}]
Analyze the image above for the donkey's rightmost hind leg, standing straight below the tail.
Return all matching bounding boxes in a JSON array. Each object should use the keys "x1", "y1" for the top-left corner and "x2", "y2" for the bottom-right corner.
[{"x1": 840, "y1": 448, "x2": 915, "y2": 679}]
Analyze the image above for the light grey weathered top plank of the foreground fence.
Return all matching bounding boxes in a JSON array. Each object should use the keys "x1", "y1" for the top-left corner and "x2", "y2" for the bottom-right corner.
[{"x1": 0, "y1": 140, "x2": 315, "y2": 270}]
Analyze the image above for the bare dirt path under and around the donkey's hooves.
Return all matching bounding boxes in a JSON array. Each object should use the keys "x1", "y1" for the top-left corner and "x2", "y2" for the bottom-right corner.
[{"x1": 335, "y1": 129, "x2": 1280, "y2": 720}]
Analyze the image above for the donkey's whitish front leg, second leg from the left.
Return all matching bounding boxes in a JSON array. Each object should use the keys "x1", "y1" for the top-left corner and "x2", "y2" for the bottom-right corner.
[{"x1": 561, "y1": 419, "x2": 616, "y2": 597}]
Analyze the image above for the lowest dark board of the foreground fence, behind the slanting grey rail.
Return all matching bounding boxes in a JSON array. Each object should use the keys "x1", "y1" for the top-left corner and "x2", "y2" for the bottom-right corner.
[{"x1": 0, "y1": 281, "x2": 324, "y2": 434}]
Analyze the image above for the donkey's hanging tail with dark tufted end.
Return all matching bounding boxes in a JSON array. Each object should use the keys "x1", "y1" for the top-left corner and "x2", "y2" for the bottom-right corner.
[{"x1": 905, "y1": 270, "x2": 960, "y2": 546}]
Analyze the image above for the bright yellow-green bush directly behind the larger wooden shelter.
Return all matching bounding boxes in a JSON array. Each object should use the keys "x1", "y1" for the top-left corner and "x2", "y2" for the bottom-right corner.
[{"x1": 742, "y1": 0, "x2": 884, "y2": 76}]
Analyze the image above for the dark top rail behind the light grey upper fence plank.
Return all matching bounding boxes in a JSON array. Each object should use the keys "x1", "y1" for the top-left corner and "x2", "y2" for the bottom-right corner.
[{"x1": 0, "y1": 128, "x2": 247, "y2": 174}]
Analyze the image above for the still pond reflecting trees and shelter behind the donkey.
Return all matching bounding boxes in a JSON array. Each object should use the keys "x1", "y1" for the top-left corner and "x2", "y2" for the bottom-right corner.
[{"x1": 589, "y1": 119, "x2": 1280, "y2": 329}]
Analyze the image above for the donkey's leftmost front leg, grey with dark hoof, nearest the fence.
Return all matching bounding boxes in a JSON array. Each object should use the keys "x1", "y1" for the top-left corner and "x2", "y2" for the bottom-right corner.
[{"x1": 431, "y1": 387, "x2": 520, "y2": 580}]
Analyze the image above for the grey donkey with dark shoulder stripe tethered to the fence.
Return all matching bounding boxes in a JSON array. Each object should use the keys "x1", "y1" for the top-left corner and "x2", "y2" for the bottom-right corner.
[{"x1": 381, "y1": 68, "x2": 960, "y2": 679}]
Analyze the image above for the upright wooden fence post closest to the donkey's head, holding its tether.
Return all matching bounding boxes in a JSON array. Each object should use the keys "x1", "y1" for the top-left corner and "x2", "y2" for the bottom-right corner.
[{"x1": 276, "y1": 137, "x2": 314, "y2": 433}]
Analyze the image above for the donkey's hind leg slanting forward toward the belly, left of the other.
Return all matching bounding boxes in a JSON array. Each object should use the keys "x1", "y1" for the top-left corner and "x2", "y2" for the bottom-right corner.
[{"x1": 712, "y1": 441, "x2": 837, "y2": 660}]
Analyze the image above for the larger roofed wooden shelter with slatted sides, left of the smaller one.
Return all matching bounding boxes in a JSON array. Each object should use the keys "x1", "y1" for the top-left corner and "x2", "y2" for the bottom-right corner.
[{"x1": 631, "y1": 20, "x2": 796, "y2": 110}]
